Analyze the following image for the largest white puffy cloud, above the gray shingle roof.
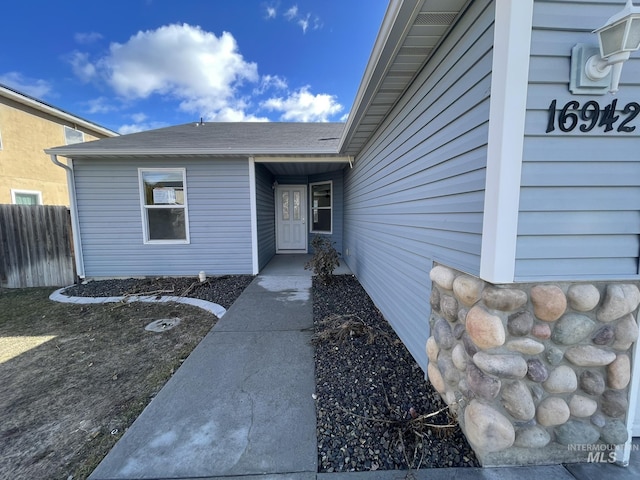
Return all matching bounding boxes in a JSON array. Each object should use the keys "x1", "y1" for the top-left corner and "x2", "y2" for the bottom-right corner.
[{"x1": 75, "y1": 24, "x2": 259, "y2": 120}]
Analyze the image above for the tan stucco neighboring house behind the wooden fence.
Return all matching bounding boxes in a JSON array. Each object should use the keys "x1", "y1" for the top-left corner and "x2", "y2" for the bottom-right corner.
[{"x1": 0, "y1": 85, "x2": 117, "y2": 205}]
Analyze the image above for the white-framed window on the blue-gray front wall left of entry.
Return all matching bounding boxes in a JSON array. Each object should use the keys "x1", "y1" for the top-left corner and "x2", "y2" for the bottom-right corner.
[{"x1": 138, "y1": 168, "x2": 189, "y2": 243}]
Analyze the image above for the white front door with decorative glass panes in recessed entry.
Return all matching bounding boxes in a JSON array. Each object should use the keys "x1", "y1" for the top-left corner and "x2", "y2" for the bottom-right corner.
[{"x1": 276, "y1": 185, "x2": 307, "y2": 253}]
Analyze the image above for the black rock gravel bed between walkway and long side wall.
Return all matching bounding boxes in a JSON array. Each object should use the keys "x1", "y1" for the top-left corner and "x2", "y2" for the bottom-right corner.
[{"x1": 313, "y1": 275, "x2": 479, "y2": 472}]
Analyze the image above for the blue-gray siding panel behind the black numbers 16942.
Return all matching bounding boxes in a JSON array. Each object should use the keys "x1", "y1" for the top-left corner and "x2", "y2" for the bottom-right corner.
[{"x1": 515, "y1": 0, "x2": 640, "y2": 281}]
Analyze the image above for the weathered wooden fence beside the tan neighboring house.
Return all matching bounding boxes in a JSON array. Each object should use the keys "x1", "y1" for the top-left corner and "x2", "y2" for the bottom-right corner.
[{"x1": 0, "y1": 205, "x2": 76, "y2": 288}]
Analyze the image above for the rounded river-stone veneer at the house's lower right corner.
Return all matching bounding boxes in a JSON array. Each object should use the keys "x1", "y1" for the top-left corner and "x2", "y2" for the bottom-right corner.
[{"x1": 426, "y1": 265, "x2": 640, "y2": 466}]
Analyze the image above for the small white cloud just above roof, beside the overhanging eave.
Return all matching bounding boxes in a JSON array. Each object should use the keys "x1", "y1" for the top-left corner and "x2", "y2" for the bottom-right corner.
[{"x1": 262, "y1": 86, "x2": 343, "y2": 122}]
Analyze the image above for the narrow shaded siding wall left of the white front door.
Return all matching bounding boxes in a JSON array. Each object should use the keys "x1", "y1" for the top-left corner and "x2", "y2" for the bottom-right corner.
[{"x1": 256, "y1": 164, "x2": 276, "y2": 270}]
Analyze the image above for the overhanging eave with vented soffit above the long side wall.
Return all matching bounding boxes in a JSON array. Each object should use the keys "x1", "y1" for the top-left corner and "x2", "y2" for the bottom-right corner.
[{"x1": 340, "y1": 0, "x2": 473, "y2": 155}]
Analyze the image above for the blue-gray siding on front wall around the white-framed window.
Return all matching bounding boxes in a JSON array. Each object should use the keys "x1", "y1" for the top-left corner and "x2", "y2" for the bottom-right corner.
[{"x1": 74, "y1": 159, "x2": 252, "y2": 278}]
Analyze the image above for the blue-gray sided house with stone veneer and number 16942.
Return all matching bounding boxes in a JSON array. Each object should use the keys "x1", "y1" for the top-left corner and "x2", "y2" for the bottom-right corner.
[{"x1": 48, "y1": 0, "x2": 640, "y2": 465}]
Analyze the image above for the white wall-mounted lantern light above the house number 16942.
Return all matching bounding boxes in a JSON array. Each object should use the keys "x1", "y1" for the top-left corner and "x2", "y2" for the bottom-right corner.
[{"x1": 569, "y1": 0, "x2": 640, "y2": 95}]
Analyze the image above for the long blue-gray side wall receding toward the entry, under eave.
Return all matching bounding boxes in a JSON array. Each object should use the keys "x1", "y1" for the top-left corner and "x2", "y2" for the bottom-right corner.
[{"x1": 343, "y1": 0, "x2": 494, "y2": 368}]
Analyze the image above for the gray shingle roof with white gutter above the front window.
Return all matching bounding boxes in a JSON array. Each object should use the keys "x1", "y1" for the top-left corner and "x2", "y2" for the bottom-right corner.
[{"x1": 46, "y1": 122, "x2": 344, "y2": 158}]
